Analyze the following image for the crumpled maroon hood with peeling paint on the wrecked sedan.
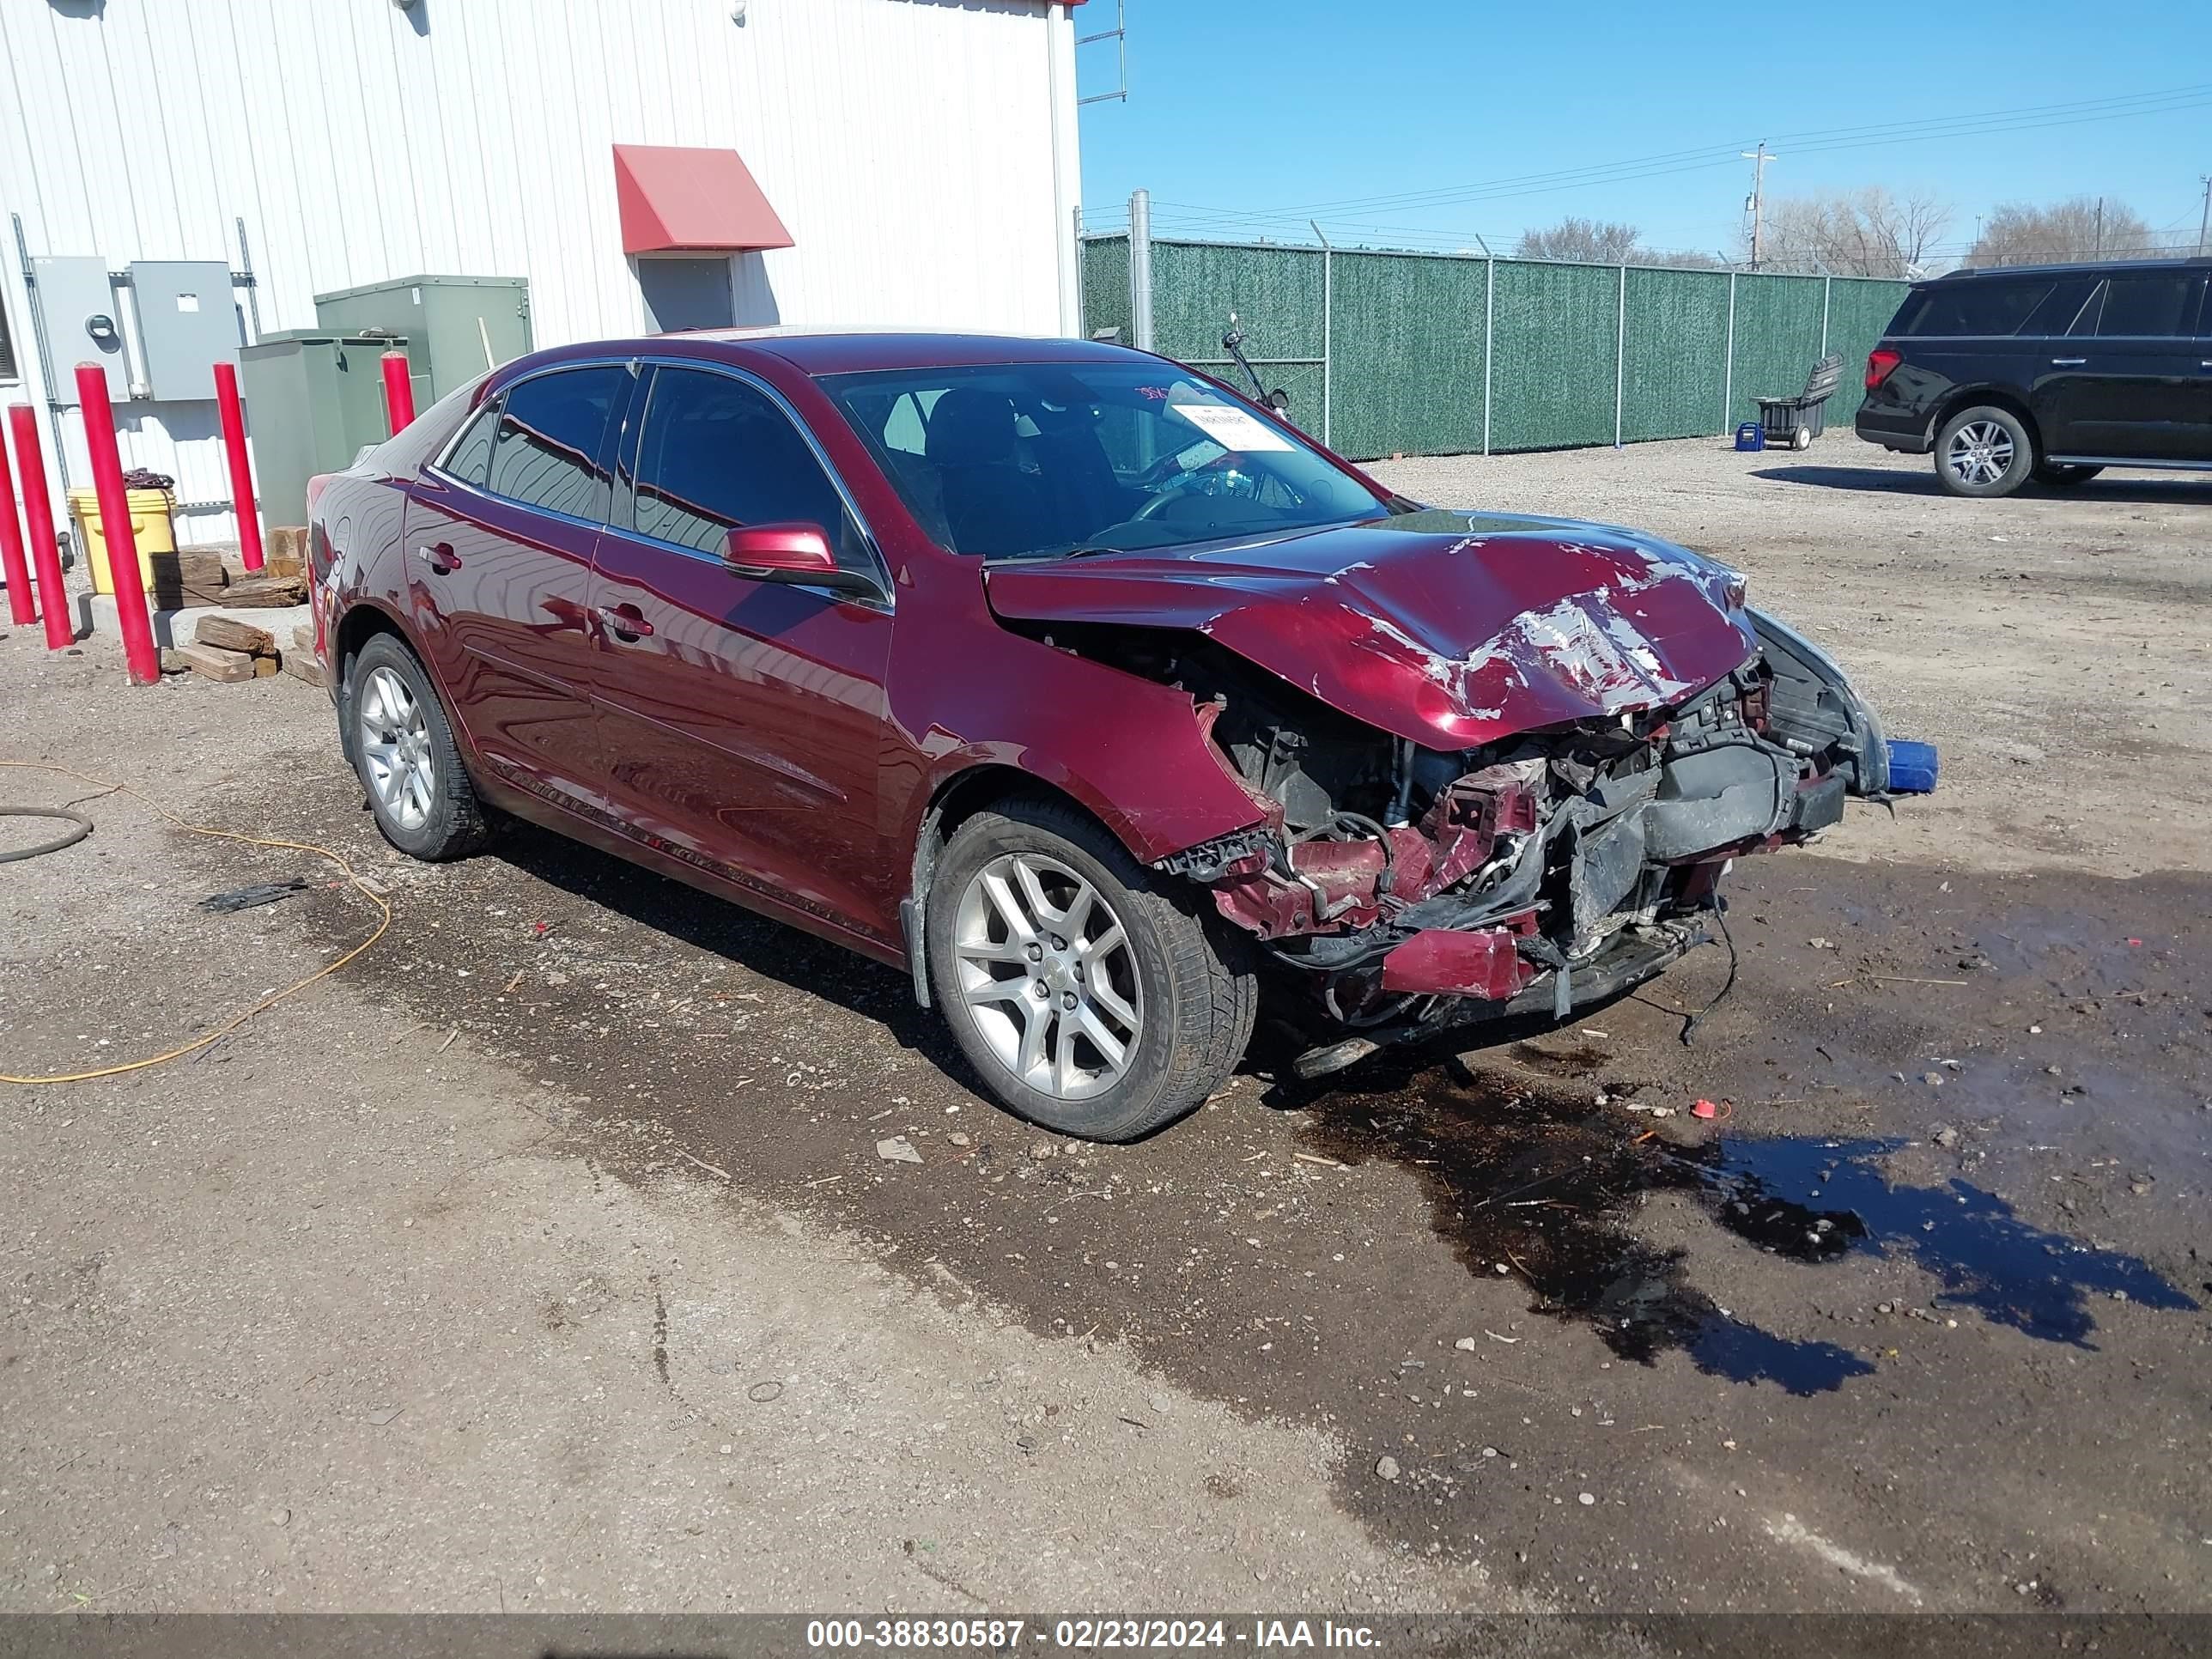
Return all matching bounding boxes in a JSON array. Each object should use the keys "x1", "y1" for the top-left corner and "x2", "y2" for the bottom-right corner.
[{"x1": 984, "y1": 508, "x2": 1759, "y2": 750}]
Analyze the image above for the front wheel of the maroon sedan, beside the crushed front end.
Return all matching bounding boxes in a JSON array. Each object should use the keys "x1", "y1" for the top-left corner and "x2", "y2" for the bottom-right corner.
[{"x1": 927, "y1": 801, "x2": 1259, "y2": 1141}]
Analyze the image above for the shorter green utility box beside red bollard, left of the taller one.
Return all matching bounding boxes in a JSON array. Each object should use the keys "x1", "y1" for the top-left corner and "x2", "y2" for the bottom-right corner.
[{"x1": 239, "y1": 338, "x2": 407, "y2": 539}]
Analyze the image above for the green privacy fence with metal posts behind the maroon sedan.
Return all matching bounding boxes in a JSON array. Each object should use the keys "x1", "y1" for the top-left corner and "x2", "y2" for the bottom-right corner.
[{"x1": 1082, "y1": 234, "x2": 1907, "y2": 460}]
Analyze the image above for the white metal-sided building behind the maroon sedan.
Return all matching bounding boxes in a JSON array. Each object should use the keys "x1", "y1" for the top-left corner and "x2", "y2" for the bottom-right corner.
[{"x1": 0, "y1": 0, "x2": 1082, "y2": 542}]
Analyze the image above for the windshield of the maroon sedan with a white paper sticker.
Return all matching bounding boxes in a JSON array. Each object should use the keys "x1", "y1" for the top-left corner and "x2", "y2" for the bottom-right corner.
[{"x1": 821, "y1": 361, "x2": 1389, "y2": 557}]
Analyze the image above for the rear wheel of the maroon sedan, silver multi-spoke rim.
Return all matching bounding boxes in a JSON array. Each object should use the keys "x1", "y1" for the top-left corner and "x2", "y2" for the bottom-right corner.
[{"x1": 338, "y1": 633, "x2": 491, "y2": 863}]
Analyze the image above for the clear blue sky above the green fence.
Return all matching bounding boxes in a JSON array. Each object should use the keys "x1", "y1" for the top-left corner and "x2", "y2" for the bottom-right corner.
[{"x1": 1075, "y1": 0, "x2": 2212, "y2": 254}]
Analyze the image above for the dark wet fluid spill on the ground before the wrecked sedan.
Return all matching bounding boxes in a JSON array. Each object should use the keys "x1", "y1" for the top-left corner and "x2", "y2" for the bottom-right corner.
[{"x1": 1307, "y1": 1066, "x2": 2197, "y2": 1394}]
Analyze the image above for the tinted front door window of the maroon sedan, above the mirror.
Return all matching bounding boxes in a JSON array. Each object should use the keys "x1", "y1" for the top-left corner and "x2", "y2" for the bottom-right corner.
[{"x1": 633, "y1": 369, "x2": 869, "y2": 568}]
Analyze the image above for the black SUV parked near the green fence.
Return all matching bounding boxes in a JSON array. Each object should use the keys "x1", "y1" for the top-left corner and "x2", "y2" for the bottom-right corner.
[{"x1": 1858, "y1": 258, "x2": 2212, "y2": 495}]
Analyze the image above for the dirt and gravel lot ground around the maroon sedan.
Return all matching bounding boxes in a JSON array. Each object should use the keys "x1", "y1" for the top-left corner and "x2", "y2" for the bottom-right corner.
[{"x1": 0, "y1": 434, "x2": 2212, "y2": 1613}]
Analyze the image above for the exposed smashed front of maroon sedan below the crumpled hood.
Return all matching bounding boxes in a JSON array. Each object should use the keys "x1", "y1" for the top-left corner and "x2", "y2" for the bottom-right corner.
[{"x1": 1004, "y1": 613, "x2": 1887, "y2": 1073}]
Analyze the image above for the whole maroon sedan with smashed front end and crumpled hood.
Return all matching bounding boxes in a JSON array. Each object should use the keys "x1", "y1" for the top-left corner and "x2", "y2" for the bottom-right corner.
[{"x1": 312, "y1": 331, "x2": 1887, "y2": 1139}]
